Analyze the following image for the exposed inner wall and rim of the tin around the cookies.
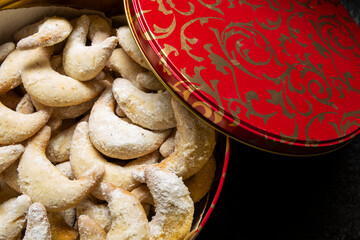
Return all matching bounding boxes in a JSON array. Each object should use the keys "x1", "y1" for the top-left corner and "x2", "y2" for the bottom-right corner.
[{"x1": 0, "y1": 0, "x2": 230, "y2": 239}]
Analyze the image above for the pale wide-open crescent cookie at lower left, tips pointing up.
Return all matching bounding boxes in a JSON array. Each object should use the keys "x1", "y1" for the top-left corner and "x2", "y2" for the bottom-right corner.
[{"x1": 18, "y1": 126, "x2": 104, "y2": 211}]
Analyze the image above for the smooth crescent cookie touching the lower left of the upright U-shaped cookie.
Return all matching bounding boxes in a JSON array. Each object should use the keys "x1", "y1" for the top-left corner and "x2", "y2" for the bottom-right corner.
[{"x1": 21, "y1": 47, "x2": 105, "y2": 107}]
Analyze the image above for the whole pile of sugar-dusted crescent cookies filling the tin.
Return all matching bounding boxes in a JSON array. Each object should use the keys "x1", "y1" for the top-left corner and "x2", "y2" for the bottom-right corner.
[{"x1": 0, "y1": 15, "x2": 216, "y2": 240}]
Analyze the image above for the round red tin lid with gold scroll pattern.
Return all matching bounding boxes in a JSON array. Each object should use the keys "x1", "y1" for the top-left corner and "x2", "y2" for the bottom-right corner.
[{"x1": 125, "y1": 0, "x2": 360, "y2": 155}]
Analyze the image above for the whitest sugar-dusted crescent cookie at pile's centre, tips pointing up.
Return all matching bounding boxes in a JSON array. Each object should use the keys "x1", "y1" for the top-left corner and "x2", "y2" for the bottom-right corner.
[{"x1": 89, "y1": 86, "x2": 170, "y2": 159}]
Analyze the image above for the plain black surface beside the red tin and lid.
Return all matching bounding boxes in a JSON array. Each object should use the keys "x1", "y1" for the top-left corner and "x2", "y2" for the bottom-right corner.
[{"x1": 197, "y1": 0, "x2": 360, "y2": 240}]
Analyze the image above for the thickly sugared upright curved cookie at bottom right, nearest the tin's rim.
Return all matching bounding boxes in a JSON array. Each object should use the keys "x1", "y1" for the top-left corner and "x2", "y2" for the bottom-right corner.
[{"x1": 134, "y1": 166, "x2": 194, "y2": 240}]
